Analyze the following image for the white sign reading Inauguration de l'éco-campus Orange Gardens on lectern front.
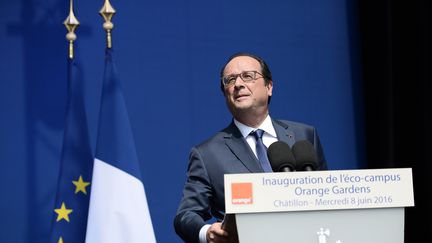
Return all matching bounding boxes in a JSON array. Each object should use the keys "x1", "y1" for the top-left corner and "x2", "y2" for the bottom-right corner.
[{"x1": 225, "y1": 168, "x2": 414, "y2": 213}]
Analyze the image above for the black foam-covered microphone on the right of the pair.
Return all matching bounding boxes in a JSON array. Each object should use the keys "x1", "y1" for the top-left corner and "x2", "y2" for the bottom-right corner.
[{"x1": 292, "y1": 140, "x2": 318, "y2": 171}]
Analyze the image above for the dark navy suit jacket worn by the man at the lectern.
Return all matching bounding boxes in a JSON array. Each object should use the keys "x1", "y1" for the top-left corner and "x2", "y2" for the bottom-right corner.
[{"x1": 174, "y1": 120, "x2": 327, "y2": 242}]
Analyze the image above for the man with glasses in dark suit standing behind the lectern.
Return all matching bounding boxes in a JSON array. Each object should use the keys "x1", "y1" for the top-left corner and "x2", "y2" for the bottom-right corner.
[{"x1": 174, "y1": 53, "x2": 327, "y2": 243}]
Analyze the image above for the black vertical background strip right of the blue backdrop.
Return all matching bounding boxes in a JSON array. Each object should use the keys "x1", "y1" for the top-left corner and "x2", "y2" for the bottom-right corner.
[{"x1": 359, "y1": 1, "x2": 432, "y2": 242}]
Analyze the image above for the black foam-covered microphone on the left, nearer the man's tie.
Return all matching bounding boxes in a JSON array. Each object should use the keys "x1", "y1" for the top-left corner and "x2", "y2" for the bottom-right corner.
[{"x1": 267, "y1": 141, "x2": 296, "y2": 172}]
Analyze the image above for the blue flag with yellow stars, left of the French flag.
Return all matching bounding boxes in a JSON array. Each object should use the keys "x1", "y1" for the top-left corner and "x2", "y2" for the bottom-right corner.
[{"x1": 50, "y1": 59, "x2": 93, "y2": 243}]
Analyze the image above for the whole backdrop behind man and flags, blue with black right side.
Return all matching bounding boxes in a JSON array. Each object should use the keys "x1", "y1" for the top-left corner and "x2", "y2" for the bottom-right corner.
[{"x1": 5, "y1": 0, "x2": 431, "y2": 243}]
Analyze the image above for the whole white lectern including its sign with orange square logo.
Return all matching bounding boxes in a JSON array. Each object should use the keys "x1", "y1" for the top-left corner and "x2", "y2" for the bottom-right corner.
[{"x1": 224, "y1": 168, "x2": 414, "y2": 243}]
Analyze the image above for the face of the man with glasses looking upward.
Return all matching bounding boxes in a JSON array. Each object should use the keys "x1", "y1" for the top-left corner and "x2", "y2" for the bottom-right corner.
[{"x1": 224, "y1": 56, "x2": 273, "y2": 117}]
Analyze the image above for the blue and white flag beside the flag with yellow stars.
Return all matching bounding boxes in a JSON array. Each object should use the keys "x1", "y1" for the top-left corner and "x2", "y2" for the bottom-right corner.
[{"x1": 86, "y1": 48, "x2": 156, "y2": 243}]
